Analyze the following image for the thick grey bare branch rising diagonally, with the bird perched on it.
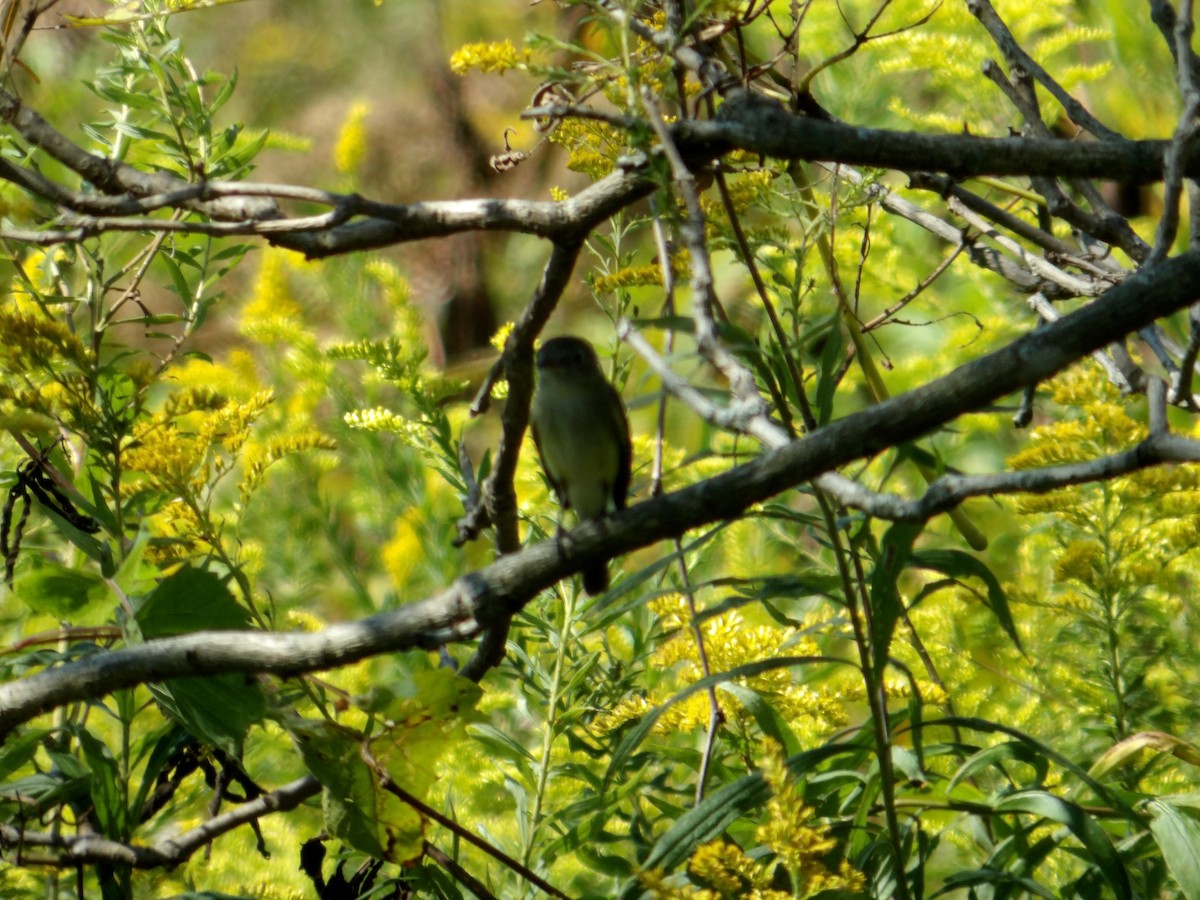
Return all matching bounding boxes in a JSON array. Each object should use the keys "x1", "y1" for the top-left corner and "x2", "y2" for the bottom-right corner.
[{"x1": 0, "y1": 250, "x2": 1200, "y2": 736}]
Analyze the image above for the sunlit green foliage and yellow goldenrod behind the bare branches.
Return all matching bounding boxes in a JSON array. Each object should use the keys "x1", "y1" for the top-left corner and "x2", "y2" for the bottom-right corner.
[{"x1": 0, "y1": 0, "x2": 1200, "y2": 898}]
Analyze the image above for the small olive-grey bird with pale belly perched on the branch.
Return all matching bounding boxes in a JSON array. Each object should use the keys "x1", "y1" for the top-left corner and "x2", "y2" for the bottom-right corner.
[{"x1": 529, "y1": 337, "x2": 632, "y2": 594}]
